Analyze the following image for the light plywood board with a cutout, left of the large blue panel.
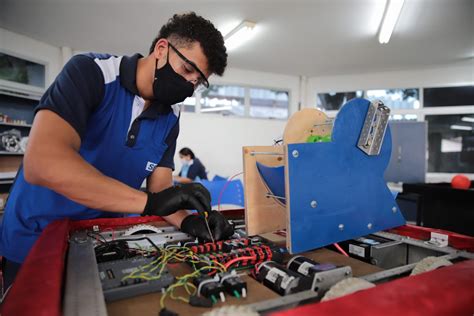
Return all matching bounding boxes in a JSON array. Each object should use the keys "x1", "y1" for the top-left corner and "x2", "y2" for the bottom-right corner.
[{"x1": 243, "y1": 146, "x2": 286, "y2": 235}]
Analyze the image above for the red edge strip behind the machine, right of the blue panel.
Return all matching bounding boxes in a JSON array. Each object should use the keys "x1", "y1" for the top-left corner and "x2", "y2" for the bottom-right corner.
[{"x1": 387, "y1": 225, "x2": 474, "y2": 252}]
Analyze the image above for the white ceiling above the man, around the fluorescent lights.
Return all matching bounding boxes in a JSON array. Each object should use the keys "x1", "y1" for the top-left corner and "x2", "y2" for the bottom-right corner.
[{"x1": 0, "y1": 0, "x2": 474, "y2": 76}]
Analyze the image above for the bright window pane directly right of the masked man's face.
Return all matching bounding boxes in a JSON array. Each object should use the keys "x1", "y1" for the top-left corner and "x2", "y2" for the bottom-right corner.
[{"x1": 201, "y1": 85, "x2": 245, "y2": 116}]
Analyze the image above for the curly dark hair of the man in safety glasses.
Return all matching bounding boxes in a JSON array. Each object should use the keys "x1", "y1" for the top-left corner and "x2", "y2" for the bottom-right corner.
[{"x1": 150, "y1": 12, "x2": 227, "y2": 76}]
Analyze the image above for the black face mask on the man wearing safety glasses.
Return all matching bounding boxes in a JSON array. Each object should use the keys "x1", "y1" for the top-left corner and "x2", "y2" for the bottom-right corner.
[{"x1": 151, "y1": 51, "x2": 194, "y2": 106}]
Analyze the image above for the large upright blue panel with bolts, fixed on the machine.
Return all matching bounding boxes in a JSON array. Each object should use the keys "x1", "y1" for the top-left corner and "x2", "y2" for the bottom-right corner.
[{"x1": 287, "y1": 99, "x2": 405, "y2": 253}]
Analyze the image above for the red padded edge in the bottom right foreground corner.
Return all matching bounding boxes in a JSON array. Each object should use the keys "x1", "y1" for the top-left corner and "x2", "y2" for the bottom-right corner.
[{"x1": 271, "y1": 260, "x2": 474, "y2": 316}]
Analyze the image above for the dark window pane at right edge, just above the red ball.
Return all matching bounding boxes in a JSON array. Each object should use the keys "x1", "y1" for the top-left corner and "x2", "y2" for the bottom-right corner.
[{"x1": 425, "y1": 114, "x2": 474, "y2": 173}]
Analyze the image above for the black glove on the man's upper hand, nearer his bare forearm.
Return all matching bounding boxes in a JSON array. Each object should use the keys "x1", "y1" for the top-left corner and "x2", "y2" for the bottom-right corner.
[{"x1": 142, "y1": 183, "x2": 211, "y2": 216}]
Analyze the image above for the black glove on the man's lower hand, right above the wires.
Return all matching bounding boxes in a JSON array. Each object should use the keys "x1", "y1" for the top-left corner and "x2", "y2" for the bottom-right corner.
[{"x1": 181, "y1": 211, "x2": 234, "y2": 240}]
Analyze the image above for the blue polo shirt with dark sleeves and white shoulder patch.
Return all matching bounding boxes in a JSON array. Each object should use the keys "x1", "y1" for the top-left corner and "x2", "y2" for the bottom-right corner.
[{"x1": 0, "y1": 54, "x2": 179, "y2": 263}]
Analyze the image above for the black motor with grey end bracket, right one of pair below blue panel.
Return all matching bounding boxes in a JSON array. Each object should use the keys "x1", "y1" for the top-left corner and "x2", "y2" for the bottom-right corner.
[{"x1": 288, "y1": 256, "x2": 352, "y2": 293}]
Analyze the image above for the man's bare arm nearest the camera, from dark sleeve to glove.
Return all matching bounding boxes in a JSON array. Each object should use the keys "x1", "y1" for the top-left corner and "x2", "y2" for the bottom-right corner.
[{"x1": 23, "y1": 110, "x2": 147, "y2": 213}]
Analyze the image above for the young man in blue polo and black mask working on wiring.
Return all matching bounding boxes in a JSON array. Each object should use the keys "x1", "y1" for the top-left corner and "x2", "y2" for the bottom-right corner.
[{"x1": 0, "y1": 13, "x2": 233, "y2": 288}]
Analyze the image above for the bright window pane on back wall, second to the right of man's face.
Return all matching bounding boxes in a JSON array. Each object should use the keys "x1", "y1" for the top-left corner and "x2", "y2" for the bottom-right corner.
[{"x1": 250, "y1": 89, "x2": 289, "y2": 119}]
